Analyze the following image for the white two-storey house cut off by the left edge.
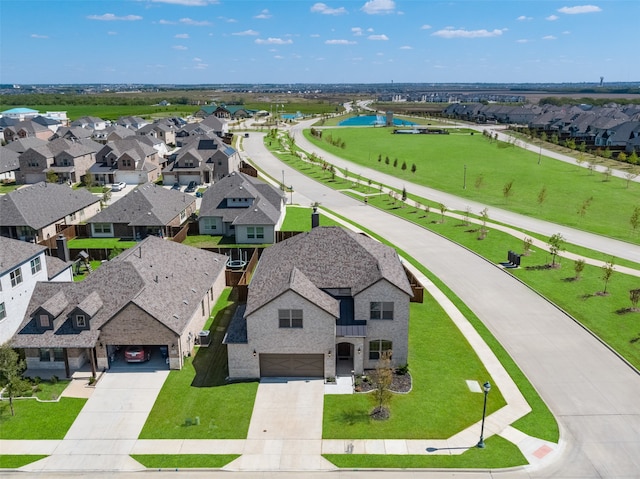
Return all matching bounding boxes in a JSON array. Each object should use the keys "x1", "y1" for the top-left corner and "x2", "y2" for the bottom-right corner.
[{"x1": 0, "y1": 236, "x2": 73, "y2": 344}]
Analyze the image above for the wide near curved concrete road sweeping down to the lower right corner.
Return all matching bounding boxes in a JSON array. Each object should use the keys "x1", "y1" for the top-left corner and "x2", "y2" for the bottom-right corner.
[{"x1": 244, "y1": 133, "x2": 640, "y2": 479}]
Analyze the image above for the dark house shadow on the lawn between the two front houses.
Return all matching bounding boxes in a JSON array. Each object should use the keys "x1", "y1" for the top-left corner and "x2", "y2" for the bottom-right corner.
[{"x1": 191, "y1": 303, "x2": 236, "y2": 388}]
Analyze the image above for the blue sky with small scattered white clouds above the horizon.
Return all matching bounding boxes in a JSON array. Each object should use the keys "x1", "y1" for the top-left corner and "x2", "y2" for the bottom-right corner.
[{"x1": 0, "y1": 0, "x2": 640, "y2": 84}]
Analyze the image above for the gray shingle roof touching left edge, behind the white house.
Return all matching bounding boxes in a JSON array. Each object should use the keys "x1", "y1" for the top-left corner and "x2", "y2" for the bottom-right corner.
[{"x1": 0, "y1": 182, "x2": 100, "y2": 230}]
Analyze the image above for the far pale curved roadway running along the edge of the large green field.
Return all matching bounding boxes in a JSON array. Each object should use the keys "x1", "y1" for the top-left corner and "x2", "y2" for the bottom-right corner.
[{"x1": 288, "y1": 120, "x2": 640, "y2": 263}]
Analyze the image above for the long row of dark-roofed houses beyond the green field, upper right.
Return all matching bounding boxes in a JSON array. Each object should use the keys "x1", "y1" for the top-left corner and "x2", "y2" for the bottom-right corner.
[{"x1": 443, "y1": 104, "x2": 640, "y2": 153}]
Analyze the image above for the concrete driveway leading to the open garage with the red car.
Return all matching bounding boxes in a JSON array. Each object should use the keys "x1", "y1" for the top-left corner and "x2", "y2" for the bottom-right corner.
[{"x1": 22, "y1": 368, "x2": 169, "y2": 473}]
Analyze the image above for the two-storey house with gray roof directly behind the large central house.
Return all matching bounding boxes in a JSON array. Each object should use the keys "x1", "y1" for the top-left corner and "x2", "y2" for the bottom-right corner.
[{"x1": 198, "y1": 172, "x2": 285, "y2": 244}]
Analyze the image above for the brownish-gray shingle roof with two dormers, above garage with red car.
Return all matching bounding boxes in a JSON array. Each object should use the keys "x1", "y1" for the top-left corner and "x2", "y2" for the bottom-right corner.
[{"x1": 12, "y1": 236, "x2": 226, "y2": 348}]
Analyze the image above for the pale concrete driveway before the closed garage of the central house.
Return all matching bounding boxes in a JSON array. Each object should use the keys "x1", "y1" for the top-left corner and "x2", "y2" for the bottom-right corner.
[{"x1": 224, "y1": 378, "x2": 335, "y2": 471}]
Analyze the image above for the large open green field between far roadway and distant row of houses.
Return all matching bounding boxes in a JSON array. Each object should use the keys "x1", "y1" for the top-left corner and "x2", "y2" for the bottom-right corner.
[{"x1": 305, "y1": 128, "x2": 640, "y2": 243}]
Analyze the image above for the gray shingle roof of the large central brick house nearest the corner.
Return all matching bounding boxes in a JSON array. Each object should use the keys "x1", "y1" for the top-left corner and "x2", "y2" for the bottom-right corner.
[{"x1": 246, "y1": 227, "x2": 412, "y2": 314}]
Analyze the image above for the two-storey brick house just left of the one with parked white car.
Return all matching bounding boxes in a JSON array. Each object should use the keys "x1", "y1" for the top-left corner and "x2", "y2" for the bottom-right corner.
[{"x1": 17, "y1": 138, "x2": 100, "y2": 184}]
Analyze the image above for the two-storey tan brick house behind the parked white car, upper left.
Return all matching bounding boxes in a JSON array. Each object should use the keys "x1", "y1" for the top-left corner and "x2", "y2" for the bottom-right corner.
[{"x1": 89, "y1": 135, "x2": 161, "y2": 185}]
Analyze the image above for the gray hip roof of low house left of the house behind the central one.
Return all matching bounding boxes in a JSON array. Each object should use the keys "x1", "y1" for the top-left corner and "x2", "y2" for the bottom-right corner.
[{"x1": 87, "y1": 183, "x2": 196, "y2": 226}]
